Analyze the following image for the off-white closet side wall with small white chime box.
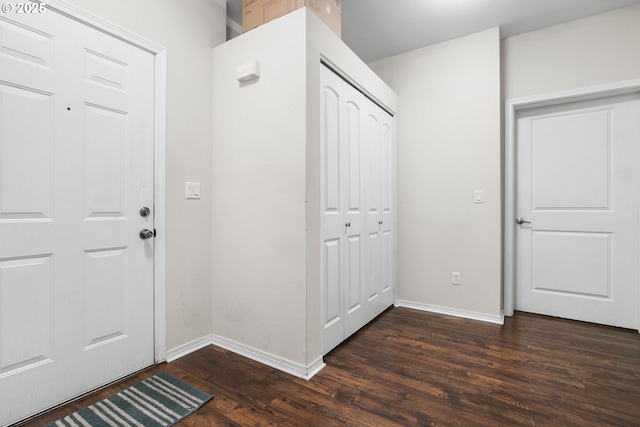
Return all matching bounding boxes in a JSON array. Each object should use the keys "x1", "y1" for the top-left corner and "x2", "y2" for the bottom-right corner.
[{"x1": 212, "y1": 12, "x2": 306, "y2": 364}]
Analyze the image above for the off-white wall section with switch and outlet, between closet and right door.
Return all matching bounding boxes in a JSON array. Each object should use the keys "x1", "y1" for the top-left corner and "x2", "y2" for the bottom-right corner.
[{"x1": 370, "y1": 28, "x2": 502, "y2": 320}]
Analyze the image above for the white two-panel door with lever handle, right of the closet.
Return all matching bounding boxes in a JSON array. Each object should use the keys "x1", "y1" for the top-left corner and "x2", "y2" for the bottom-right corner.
[{"x1": 507, "y1": 94, "x2": 640, "y2": 329}]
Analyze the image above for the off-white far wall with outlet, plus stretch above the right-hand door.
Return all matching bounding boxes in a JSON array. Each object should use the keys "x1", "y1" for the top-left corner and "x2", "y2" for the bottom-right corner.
[{"x1": 370, "y1": 6, "x2": 640, "y2": 322}]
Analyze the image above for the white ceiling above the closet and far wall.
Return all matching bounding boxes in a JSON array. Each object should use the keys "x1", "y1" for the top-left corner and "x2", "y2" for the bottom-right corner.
[{"x1": 227, "y1": 0, "x2": 640, "y2": 62}]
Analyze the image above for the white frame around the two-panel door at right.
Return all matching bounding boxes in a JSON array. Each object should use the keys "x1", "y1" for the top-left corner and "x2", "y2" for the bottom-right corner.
[{"x1": 502, "y1": 79, "x2": 640, "y2": 332}]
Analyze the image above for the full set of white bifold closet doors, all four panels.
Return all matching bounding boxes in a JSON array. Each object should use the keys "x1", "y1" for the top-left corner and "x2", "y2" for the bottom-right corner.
[{"x1": 321, "y1": 66, "x2": 394, "y2": 353}]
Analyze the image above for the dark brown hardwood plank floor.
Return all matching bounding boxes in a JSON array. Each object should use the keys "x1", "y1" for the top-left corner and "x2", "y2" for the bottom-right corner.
[{"x1": 18, "y1": 308, "x2": 640, "y2": 427}]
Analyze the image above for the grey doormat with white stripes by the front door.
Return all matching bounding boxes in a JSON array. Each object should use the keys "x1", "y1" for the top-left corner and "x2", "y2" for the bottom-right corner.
[{"x1": 47, "y1": 372, "x2": 212, "y2": 427}]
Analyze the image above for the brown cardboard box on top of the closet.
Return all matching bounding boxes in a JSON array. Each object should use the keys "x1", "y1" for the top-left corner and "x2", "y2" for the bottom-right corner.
[{"x1": 242, "y1": 0, "x2": 342, "y2": 37}]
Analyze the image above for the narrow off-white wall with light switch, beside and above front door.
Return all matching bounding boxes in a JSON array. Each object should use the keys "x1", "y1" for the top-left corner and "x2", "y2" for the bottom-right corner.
[{"x1": 71, "y1": 0, "x2": 226, "y2": 350}]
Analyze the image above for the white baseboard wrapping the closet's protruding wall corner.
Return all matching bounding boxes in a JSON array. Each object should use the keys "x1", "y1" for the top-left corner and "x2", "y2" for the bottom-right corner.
[{"x1": 212, "y1": 335, "x2": 326, "y2": 380}]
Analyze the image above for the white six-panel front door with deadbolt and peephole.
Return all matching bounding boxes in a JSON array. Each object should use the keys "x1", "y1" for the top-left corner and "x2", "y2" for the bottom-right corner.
[{"x1": 0, "y1": 10, "x2": 154, "y2": 425}]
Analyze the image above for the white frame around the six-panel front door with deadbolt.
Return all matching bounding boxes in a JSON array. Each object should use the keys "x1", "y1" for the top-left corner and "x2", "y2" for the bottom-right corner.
[{"x1": 46, "y1": 0, "x2": 167, "y2": 362}]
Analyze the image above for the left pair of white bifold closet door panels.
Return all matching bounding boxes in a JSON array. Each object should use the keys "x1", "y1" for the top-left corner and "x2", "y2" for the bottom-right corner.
[{"x1": 321, "y1": 66, "x2": 366, "y2": 353}]
